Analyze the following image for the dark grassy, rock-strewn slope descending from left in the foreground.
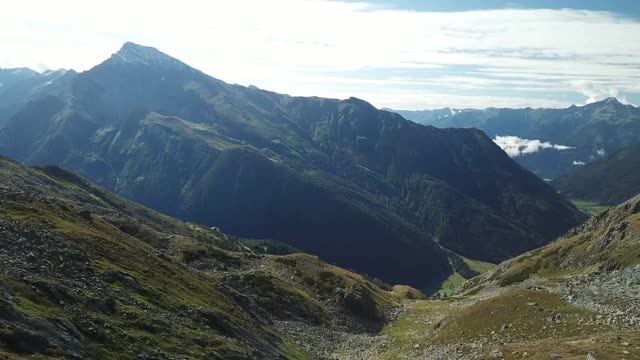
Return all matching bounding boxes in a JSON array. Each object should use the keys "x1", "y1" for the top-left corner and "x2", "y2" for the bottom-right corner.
[{"x1": 0, "y1": 158, "x2": 419, "y2": 359}]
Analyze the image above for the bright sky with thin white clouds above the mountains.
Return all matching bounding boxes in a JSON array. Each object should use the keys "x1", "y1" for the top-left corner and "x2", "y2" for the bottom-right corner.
[{"x1": 0, "y1": 0, "x2": 640, "y2": 110}]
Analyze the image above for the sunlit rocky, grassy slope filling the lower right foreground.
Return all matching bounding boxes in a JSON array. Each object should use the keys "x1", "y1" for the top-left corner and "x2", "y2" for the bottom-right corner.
[{"x1": 348, "y1": 197, "x2": 640, "y2": 360}]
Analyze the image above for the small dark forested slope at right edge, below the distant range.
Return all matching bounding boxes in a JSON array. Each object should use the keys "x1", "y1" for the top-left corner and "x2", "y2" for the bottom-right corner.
[{"x1": 552, "y1": 144, "x2": 640, "y2": 205}]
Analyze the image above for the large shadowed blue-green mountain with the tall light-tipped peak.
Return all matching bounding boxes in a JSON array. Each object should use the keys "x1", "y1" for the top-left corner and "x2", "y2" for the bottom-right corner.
[{"x1": 0, "y1": 43, "x2": 583, "y2": 289}]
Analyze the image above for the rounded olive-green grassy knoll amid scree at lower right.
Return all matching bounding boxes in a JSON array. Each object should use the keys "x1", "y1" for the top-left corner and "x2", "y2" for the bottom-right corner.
[{"x1": 379, "y1": 288, "x2": 640, "y2": 359}]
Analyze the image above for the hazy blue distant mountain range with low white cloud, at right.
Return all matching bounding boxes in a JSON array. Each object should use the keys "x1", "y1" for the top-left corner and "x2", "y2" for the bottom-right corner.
[{"x1": 392, "y1": 98, "x2": 640, "y2": 179}]
